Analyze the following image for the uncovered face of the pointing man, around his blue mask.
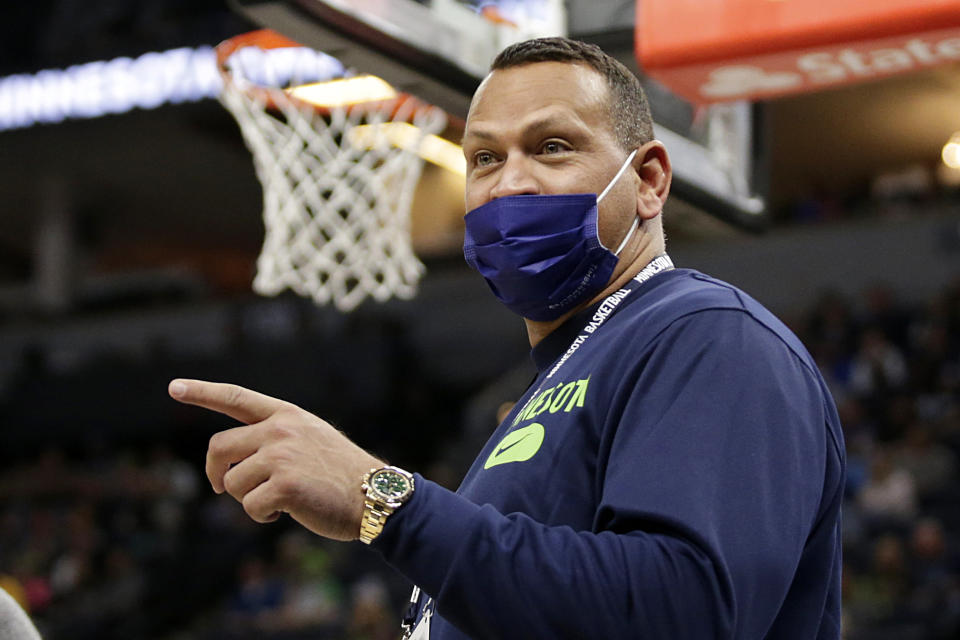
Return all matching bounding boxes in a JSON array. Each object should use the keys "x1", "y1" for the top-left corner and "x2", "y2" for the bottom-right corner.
[{"x1": 463, "y1": 62, "x2": 639, "y2": 247}]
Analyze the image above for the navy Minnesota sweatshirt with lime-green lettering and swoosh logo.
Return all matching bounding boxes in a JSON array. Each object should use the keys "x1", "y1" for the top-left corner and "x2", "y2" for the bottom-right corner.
[{"x1": 374, "y1": 269, "x2": 845, "y2": 640}]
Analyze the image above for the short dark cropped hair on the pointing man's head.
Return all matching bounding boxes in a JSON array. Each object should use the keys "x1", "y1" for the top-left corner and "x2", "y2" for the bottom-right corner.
[{"x1": 490, "y1": 37, "x2": 653, "y2": 151}]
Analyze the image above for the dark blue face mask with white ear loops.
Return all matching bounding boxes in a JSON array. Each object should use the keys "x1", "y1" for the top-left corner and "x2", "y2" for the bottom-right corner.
[{"x1": 463, "y1": 150, "x2": 640, "y2": 321}]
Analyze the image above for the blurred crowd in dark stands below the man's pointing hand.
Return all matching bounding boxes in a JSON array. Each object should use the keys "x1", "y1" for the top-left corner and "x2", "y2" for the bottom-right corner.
[{"x1": 0, "y1": 445, "x2": 406, "y2": 640}]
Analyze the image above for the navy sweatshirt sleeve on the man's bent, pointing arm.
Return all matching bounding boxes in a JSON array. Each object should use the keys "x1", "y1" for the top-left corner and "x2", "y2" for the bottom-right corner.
[{"x1": 375, "y1": 311, "x2": 826, "y2": 640}]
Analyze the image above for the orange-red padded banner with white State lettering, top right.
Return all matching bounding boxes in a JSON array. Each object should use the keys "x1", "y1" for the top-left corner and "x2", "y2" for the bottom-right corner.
[{"x1": 634, "y1": 0, "x2": 960, "y2": 104}]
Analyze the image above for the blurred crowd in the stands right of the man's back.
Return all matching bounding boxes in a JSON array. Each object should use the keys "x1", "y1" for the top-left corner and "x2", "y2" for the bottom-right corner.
[{"x1": 794, "y1": 281, "x2": 960, "y2": 640}]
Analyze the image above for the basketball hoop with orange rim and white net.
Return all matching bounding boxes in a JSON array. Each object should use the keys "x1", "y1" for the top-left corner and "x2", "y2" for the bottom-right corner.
[{"x1": 217, "y1": 30, "x2": 447, "y2": 311}]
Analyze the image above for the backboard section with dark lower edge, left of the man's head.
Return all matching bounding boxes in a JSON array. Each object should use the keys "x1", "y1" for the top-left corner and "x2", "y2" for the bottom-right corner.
[{"x1": 231, "y1": 0, "x2": 566, "y2": 118}]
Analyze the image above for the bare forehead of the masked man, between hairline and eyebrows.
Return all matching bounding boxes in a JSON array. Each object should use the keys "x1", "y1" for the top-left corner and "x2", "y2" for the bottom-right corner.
[{"x1": 464, "y1": 62, "x2": 610, "y2": 138}]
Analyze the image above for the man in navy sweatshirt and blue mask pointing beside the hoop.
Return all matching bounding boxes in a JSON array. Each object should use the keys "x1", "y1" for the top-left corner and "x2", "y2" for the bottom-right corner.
[{"x1": 171, "y1": 38, "x2": 844, "y2": 640}]
